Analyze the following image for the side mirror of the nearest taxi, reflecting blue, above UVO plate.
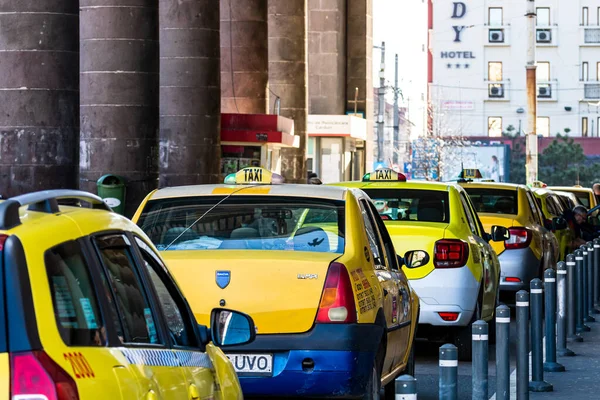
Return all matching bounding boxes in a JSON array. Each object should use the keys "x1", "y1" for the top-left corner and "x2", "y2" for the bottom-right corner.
[{"x1": 210, "y1": 308, "x2": 256, "y2": 347}]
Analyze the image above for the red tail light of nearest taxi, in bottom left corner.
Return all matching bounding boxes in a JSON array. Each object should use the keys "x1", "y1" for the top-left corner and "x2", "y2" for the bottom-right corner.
[{"x1": 10, "y1": 351, "x2": 79, "y2": 400}]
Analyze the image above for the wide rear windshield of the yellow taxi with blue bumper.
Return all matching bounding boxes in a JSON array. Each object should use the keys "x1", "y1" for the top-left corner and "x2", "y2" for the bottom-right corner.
[{"x1": 138, "y1": 196, "x2": 345, "y2": 254}]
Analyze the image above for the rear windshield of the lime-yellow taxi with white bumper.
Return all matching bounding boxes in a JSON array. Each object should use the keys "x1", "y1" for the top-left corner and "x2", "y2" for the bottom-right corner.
[{"x1": 363, "y1": 189, "x2": 450, "y2": 224}]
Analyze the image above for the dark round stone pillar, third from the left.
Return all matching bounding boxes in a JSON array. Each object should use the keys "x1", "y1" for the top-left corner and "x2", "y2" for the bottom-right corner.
[{"x1": 159, "y1": 0, "x2": 221, "y2": 187}]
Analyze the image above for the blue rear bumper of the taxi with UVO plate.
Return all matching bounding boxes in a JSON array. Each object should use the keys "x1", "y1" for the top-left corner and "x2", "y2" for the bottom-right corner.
[{"x1": 224, "y1": 324, "x2": 383, "y2": 398}]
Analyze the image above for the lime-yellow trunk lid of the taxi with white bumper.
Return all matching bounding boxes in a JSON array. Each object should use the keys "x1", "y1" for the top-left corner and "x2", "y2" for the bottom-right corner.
[{"x1": 385, "y1": 222, "x2": 448, "y2": 279}]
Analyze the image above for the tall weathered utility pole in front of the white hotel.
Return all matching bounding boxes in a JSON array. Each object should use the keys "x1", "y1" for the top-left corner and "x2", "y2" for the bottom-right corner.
[{"x1": 525, "y1": 0, "x2": 538, "y2": 184}]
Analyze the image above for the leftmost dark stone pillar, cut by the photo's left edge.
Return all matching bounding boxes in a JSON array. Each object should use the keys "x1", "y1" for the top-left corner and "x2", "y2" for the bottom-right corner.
[{"x1": 0, "y1": 0, "x2": 79, "y2": 194}]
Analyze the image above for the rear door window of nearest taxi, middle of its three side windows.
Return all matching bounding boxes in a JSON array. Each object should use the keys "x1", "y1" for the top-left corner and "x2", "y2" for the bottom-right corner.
[{"x1": 96, "y1": 235, "x2": 159, "y2": 344}]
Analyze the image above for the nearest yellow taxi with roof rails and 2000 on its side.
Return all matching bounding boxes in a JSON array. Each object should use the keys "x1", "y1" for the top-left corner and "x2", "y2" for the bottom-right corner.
[{"x1": 0, "y1": 190, "x2": 254, "y2": 400}]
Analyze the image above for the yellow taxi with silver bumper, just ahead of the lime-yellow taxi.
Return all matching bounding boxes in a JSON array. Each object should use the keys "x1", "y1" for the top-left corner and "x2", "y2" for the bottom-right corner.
[{"x1": 460, "y1": 179, "x2": 559, "y2": 296}]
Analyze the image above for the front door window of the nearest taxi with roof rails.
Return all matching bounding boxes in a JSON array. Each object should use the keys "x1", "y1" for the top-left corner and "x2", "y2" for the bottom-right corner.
[{"x1": 136, "y1": 238, "x2": 198, "y2": 347}]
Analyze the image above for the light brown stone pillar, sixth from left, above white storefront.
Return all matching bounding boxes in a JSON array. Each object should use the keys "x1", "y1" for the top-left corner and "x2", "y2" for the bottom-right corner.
[{"x1": 308, "y1": 0, "x2": 344, "y2": 115}]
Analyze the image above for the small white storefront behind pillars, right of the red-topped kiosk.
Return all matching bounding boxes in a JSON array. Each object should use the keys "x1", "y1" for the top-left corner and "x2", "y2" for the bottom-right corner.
[{"x1": 307, "y1": 115, "x2": 367, "y2": 183}]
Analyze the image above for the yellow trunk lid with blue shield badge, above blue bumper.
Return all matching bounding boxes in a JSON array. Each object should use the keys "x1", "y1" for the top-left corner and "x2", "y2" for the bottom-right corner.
[{"x1": 162, "y1": 250, "x2": 340, "y2": 334}]
